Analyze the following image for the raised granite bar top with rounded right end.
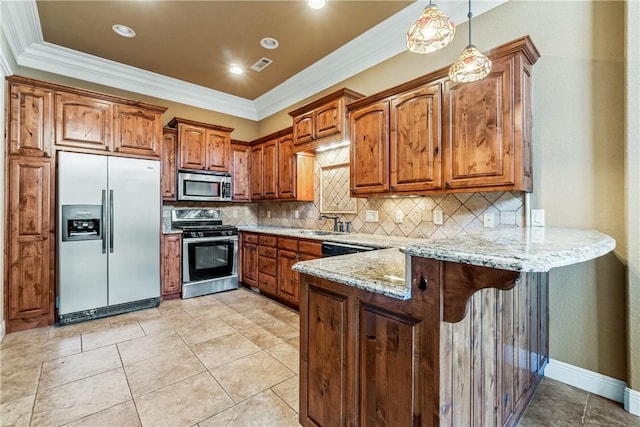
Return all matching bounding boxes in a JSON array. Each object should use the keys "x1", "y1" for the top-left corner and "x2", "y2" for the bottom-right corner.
[{"x1": 403, "y1": 227, "x2": 616, "y2": 272}]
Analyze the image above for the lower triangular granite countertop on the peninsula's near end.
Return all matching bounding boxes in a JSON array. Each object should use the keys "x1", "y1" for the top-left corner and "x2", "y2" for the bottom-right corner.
[{"x1": 293, "y1": 248, "x2": 411, "y2": 299}]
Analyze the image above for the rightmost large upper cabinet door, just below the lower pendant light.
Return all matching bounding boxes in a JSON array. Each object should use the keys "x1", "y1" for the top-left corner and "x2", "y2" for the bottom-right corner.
[{"x1": 443, "y1": 56, "x2": 515, "y2": 191}]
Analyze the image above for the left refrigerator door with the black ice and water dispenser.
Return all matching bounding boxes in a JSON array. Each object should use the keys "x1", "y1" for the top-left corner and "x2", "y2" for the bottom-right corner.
[{"x1": 57, "y1": 152, "x2": 108, "y2": 314}]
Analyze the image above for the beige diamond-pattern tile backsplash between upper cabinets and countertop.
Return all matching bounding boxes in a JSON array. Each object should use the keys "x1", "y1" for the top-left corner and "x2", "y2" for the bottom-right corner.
[{"x1": 163, "y1": 147, "x2": 525, "y2": 238}]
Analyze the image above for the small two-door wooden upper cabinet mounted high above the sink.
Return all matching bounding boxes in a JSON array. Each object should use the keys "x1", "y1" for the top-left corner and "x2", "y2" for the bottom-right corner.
[{"x1": 289, "y1": 89, "x2": 363, "y2": 152}]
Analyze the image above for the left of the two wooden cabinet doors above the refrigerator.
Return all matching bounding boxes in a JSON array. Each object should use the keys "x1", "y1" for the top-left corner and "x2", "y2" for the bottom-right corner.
[{"x1": 56, "y1": 93, "x2": 113, "y2": 151}]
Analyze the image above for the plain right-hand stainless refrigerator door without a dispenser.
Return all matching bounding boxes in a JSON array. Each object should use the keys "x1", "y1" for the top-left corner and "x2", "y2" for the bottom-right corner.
[{"x1": 107, "y1": 157, "x2": 161, "y2": 305}]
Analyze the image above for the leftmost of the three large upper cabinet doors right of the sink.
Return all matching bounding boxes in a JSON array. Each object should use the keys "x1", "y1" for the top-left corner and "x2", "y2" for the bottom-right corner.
[{"x1": 349, "y1": 101, "x2": 389, "y2": 196}]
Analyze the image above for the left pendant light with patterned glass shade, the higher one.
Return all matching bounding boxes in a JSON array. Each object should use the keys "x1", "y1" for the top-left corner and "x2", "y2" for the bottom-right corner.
[{"x1": 407, "y1": 0, "x2": 456, "y2": 53}]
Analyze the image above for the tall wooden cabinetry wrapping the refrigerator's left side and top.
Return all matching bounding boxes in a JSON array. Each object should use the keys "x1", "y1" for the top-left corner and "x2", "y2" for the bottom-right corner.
[{"x1": 4, "y1": 76, "x2": 165, "y2": 332}]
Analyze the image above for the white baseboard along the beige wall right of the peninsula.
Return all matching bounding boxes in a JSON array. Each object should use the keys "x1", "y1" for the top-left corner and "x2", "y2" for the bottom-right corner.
[{"x1": 544, "y1": 359, "x2": 624, "y2": 404}]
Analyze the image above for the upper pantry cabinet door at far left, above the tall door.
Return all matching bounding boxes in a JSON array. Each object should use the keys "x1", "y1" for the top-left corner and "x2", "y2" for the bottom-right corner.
[{"x1": 8, "y1": 85, "x2": 53, "y2": 157}]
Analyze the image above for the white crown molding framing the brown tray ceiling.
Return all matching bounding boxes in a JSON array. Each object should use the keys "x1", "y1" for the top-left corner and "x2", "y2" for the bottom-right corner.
[{"x1": 0, "y1": 0, "x2": 508, "y2": 121}]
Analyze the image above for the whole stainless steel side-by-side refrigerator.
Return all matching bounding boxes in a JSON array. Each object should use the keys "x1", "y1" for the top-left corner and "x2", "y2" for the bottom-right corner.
[{"x1": 56, "y1": 152, "x2": 161, "y2": 324}]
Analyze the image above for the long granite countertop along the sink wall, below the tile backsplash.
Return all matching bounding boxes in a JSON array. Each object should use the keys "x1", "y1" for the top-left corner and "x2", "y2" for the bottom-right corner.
[{"x1": 238, "y1": 225, "x2": 424, "y2": 249}]
